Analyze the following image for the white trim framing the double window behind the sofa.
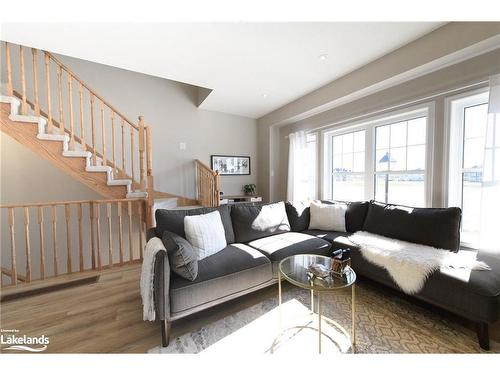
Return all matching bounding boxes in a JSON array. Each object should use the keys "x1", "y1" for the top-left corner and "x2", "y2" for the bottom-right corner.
[{"x1": 321, "y1": 102, "x2": 435, "y2": 207}]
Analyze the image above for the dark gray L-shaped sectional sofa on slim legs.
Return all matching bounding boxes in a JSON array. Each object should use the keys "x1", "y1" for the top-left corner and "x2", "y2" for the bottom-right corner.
[{"x1": 148, "y1": 201, "x2": 500, "y2": 349}]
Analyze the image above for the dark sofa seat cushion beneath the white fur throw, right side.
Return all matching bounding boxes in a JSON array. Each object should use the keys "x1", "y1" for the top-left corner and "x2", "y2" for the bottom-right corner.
[{"x1": 332, "y1": 237, "x2": 500, "y2": 322}]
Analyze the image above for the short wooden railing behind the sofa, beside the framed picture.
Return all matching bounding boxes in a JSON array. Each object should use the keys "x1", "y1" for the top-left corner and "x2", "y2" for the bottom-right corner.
[{"x1": 195, "y1": 159, "x2": 220, "y2": 207}]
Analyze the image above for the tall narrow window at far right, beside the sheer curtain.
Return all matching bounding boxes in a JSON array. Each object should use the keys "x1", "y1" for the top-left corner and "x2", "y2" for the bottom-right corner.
[{"x1": 448, "y1": 92, "x2": 488, "y2": 246}]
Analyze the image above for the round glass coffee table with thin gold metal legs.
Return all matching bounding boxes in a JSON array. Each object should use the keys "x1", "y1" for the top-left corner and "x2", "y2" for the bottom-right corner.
[{"x1": 278, "y1": 254, "x2": 356, "y2": 353}]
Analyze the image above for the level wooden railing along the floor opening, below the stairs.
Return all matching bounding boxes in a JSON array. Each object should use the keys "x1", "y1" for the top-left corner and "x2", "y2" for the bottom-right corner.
[{"x1": 0, "y1": 199, "x2": 148, "y2": 286}]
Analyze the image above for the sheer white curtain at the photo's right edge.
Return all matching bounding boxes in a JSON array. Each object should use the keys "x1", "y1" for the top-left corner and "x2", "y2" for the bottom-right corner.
[{"x1": 479, "y1": 74, "x2": 500, "y2": 252}]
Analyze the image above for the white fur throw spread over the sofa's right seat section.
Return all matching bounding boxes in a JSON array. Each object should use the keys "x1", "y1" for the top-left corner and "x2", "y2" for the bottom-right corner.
[{"x1": 348, "y1": 231, "x2": 491, "y2": 294}]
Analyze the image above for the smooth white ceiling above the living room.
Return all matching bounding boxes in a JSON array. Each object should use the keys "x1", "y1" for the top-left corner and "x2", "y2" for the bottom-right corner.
[{"x1": 2, "y1": 22, "x2": 442, "y2": 118}]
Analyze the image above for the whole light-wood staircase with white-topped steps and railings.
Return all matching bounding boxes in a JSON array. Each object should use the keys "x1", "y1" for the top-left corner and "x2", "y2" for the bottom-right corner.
[{"x1": 0, "y1": 42, "x2": 220, "y2": 297}]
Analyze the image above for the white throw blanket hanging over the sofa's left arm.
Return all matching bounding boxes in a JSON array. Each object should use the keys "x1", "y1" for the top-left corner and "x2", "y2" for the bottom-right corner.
[{"x1": 141, "y1": 237, "x2": 166, "y2": 321}]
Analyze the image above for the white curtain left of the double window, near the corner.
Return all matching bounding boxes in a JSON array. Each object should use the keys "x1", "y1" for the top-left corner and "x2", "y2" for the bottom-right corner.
[{"x1": 287, "y1": 130, "x2": 316, "y2": 202}]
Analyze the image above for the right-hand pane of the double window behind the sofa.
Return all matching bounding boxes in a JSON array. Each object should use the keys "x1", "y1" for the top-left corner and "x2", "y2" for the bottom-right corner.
[{"x1": 375, "y1": 117, "x2": 427, "y2": 207}]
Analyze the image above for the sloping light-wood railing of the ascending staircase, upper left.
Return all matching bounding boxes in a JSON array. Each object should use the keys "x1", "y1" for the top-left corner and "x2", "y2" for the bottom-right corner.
[{"x1": 5, "y1": 42, "x2": 153, "y2": 197}]
